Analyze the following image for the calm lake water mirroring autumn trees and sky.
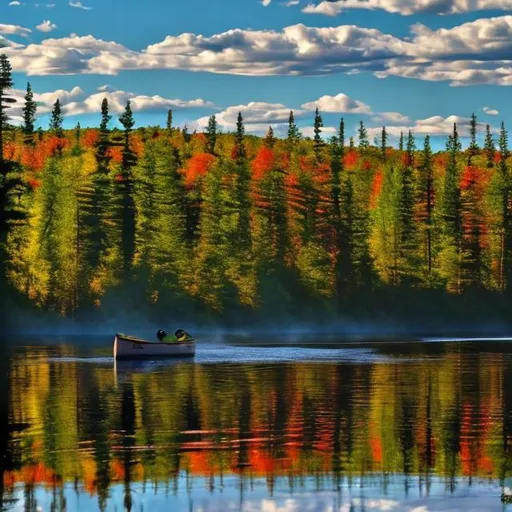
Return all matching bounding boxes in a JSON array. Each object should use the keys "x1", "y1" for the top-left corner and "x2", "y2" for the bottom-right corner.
[{"x1": 0, "y1": 339, "x2": 512, "y2": 512}]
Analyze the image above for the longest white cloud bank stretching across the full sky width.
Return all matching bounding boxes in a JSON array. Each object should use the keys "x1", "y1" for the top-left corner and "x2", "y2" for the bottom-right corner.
[{"x1": 1, "y1": 16, "x2": 512, "y2": 86}]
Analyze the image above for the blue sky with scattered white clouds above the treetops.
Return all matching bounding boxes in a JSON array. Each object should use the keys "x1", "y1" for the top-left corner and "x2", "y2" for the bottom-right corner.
[{"x1": 0, "y1": 0, "x2": 512, "y2": 146}]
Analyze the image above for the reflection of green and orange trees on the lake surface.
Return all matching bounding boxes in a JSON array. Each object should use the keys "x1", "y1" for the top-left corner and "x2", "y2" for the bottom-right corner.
[{"x1": 6, "y1": 350, "x2": 512, "y2": 509}]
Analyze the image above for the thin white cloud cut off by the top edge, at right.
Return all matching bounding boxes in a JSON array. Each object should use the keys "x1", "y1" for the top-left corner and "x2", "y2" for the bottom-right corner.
[{"x1": 302, "y1": 0, "x2": 512, "y2": 16}]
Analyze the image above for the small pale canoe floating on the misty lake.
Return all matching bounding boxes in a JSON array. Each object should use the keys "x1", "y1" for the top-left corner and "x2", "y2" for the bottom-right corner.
[{"x1": 114, "y1": 333, "x2": 196, "y2": 359}]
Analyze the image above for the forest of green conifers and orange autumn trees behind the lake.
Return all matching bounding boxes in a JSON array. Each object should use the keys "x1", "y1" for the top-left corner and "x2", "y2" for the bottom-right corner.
[{"x1": 0, "y1": 55, "x2": 512, "y2": 328}]
